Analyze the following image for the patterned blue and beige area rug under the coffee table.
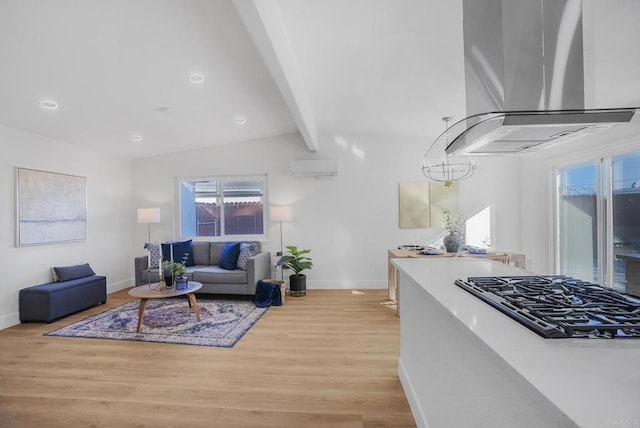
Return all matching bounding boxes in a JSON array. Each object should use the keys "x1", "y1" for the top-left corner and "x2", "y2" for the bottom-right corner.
[{"x1": 45, "y1": 297, "x2": 268, "y2": 348}]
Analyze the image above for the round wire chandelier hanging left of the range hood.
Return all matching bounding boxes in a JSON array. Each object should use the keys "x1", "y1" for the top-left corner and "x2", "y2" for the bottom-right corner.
[{"x1": 422, "y1": 116, "x2": 476, "y2": 187}]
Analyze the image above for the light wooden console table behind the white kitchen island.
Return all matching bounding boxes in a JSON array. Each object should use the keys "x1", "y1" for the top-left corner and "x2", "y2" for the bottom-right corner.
[{"x1": 387, "y1": 248, "x2": 526, "y2": 314}]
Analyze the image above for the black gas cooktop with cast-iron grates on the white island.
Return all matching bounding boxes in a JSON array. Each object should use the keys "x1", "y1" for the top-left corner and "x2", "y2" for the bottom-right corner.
[{"x1": 455, "y1": 275, "x2": 640, "y2": 339}]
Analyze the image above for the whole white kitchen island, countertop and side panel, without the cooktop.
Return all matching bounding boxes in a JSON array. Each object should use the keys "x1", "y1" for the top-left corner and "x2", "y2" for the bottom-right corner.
[{"x1": 393, "y1": 258, "x2": 640, "y2": 428}]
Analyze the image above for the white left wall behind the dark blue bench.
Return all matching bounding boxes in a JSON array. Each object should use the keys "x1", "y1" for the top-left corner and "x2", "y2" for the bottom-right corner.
[{"x1": 0, "y1": 126, "x2": 133, "y2": 328}]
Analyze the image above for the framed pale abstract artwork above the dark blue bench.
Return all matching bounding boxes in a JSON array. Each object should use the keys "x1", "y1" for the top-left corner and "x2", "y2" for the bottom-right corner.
[{"x1": 15, "y1": 167, "x2": 87, "y2": 246}]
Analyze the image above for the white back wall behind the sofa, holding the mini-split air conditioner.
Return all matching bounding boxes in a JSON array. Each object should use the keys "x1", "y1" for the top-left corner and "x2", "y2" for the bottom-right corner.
[{"x1": 133, "y1": 134, "x2": 521, "y2": 288}]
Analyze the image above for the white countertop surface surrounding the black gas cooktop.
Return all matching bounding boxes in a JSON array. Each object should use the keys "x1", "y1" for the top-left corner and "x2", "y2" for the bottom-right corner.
[{"x1": 393, "y1": 258, "x2": 640, "y2": 428}]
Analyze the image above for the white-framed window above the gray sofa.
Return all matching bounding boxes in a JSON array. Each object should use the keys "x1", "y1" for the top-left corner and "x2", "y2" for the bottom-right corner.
[{"x1": 178, "y1": 176, "x2": 267, "y2": 239}]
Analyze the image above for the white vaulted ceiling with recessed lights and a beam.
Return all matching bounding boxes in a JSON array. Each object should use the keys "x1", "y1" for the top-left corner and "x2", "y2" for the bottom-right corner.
[{"x1": 0, "y1": 0, "x2": 465, "y2": 159}]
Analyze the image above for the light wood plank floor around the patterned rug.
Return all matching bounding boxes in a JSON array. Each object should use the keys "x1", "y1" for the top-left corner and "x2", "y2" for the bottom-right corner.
[{"x1": 0, "y1": 290, "x2": 415, "y2": 428}]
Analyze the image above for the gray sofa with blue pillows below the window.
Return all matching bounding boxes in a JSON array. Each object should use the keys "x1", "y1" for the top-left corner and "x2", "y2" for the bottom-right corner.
[{"x1": 134, "y1": 241, "x2": 271, "y2": 295}]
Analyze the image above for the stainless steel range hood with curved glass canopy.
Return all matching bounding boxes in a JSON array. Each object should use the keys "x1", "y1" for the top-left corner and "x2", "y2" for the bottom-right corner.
[{"x1": 441, "y1": 0, "x2": 640, "y2": 155}]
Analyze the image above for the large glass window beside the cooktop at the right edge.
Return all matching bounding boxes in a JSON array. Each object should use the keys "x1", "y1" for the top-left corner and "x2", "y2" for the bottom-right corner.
[{"x1": 556, "y1": 152, "x2": 640, "y2": 291}]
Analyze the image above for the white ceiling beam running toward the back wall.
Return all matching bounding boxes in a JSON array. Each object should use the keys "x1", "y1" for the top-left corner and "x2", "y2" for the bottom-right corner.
[{"x1": 233, "y1": 0, "x2": 318, "y2": 152}]
